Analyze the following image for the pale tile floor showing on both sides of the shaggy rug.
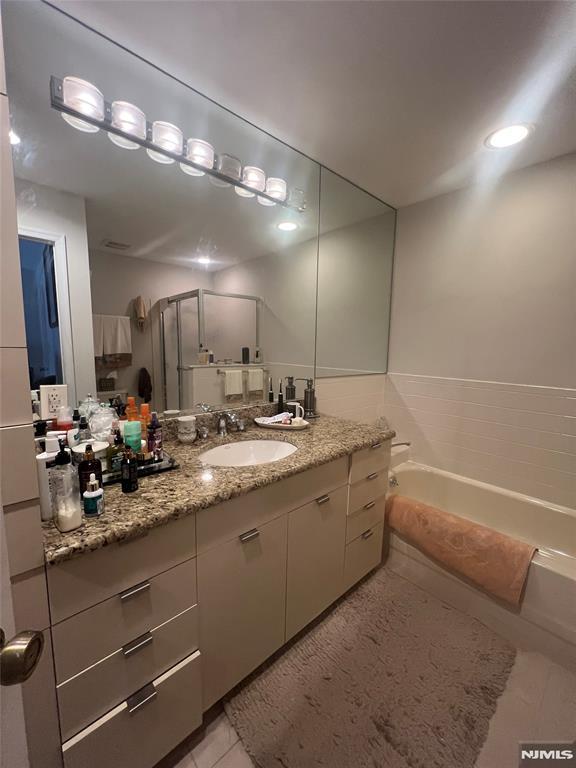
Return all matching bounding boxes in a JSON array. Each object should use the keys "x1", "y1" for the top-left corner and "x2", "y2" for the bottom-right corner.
[{"x1": 158, "y1": 651, "x2": 576, "y2": 768}]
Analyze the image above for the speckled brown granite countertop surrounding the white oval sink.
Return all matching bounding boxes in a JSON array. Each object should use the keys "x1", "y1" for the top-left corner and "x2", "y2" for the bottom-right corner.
[{"x1": 43, "y1": 416, "x2": 395, "y2": 565}]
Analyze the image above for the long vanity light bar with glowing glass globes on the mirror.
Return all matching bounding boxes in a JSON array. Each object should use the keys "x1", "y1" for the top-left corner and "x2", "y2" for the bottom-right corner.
[{"x1": 50, "y1": 75, "x2": 306, "y2": 213}]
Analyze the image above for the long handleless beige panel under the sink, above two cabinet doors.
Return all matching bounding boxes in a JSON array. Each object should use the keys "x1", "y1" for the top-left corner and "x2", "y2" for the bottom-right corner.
[{"x1": 196, "y1": 456, "x2": 348, "y2": 554}]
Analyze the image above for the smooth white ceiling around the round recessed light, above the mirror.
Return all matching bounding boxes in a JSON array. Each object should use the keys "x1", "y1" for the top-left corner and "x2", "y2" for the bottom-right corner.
[{"x1": 49, "y1": 0, "x2": 576, "y2": 206}]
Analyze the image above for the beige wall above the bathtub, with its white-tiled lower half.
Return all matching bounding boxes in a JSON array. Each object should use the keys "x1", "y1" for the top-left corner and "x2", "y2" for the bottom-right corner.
[{"x1": 384, "y1": 154, "x2": 576, "y2": 507}]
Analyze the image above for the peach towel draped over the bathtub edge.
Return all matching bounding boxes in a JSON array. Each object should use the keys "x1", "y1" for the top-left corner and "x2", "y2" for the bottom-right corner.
[{"x1": 386, "y1": 495, "x2": 536, "y2": 608}]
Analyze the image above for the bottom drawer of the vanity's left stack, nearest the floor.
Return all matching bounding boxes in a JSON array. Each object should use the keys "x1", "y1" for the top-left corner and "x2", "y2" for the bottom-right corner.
[{"x1": 62, "y1": 651, "x2": 202, "y2": 768}]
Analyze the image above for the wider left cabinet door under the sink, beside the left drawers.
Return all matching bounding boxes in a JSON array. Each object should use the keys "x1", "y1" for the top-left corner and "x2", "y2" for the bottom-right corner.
[{"x1": 197, "y1": 515, "x2": 287, "y2": 710}]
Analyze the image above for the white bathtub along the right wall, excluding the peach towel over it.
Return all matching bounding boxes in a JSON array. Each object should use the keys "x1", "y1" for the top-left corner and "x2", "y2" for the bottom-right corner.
[{"x1": 386, "y1": 461, "x2": 576, "y2": 670}]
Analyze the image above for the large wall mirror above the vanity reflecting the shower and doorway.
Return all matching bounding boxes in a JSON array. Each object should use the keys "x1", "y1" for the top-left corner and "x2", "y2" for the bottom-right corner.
[{"x1": 3, "y1": 0, "x2": 395, "y2": 411}]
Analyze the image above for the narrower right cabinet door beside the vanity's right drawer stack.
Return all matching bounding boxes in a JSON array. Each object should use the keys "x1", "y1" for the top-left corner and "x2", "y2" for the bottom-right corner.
[{"x1": 286, "y1": 486, "x2": 348, "y2": 640}]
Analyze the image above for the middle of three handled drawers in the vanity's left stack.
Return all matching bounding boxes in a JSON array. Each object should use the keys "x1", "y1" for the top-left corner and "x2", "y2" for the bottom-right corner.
[{"x1": 57, "y1": 606, "x2": 198, "y2": 739}]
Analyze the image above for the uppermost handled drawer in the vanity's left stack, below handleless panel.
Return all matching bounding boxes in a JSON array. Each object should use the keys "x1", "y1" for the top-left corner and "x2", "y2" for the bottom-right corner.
[{"x1": 52, "y1": 558, "x2": 196, "y2": 683}]
